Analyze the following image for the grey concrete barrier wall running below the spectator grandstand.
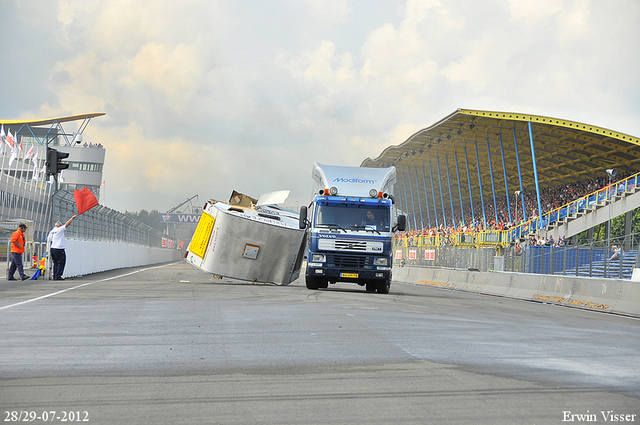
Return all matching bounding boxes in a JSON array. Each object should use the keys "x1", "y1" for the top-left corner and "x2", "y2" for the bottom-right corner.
[{"x1": 393, "y1": 267, "x2": 640, "y2": 317}]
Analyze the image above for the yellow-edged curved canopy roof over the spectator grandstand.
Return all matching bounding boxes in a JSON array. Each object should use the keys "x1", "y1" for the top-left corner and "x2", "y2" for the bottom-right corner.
[{"x1": 361, "y1": 109, "x2": 640, "y2": 229}]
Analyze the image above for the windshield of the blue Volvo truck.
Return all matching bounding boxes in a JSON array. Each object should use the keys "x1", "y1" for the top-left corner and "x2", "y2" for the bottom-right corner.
[{"x1": 315, "y1": 203, "x2": 391, "y2": 232}]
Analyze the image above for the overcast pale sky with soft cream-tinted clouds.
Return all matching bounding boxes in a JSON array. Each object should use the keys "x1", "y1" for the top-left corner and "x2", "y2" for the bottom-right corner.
[{"x1": 0, "y1": 0, "x2": 640, "y2": 211}]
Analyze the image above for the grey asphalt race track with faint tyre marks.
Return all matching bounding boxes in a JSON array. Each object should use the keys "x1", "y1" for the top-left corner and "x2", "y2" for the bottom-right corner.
[{"x1": 0, "y1": 263, "x2": 640, "y2": 424}]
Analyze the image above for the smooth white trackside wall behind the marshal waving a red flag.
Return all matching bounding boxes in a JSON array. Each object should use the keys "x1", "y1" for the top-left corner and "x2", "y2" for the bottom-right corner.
[{"x1": 57, "y1": 239, "x2": 183, "y2": 277}]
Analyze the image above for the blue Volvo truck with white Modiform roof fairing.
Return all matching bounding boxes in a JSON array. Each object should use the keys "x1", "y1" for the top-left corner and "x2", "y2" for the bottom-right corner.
[{"x1": 300, "y1": 163, "x2": 406, "y2": 294}]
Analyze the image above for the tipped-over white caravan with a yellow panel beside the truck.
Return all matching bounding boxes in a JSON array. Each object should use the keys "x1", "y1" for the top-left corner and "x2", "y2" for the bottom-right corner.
[{"x1": 185, "y1": 192, "x2": 305, "y2": 285}]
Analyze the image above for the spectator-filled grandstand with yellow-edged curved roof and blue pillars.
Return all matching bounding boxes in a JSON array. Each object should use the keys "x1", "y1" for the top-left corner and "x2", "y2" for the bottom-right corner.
[{"x1": 361, "y1": 109, "x2": 640, "y2": 277}]
